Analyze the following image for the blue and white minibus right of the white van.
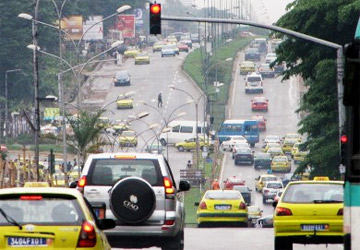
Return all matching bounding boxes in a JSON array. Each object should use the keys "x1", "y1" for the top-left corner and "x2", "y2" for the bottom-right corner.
[{"x1": 218, "y1": 120, "x2": 259, "y2": 147}]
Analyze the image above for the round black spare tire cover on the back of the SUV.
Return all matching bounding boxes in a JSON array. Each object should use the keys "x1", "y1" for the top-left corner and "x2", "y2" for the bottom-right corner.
[{"x1": 110, "y1": 177, "x2": 156, "y2": 224}]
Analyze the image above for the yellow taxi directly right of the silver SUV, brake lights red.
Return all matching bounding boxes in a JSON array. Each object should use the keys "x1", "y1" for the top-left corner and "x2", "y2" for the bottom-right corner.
[{"x1": 195, "y1": 190, "x2": 248, "y2": 227}]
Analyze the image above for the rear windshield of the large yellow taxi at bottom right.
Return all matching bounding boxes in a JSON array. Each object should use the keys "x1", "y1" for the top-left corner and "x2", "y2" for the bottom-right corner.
[{"x1": 282, "y1": 183, "x2": 344, "y2": 203}]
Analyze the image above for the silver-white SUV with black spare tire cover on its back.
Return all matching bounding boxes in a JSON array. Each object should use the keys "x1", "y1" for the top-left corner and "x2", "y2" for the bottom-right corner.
[{"x1": 77, "y1": 153, "x2": 190, "y2": 249}]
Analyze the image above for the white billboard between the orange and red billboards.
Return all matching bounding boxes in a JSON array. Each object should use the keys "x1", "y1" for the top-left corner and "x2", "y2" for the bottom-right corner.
[{"x1": 83, "y1": 16, "x2": 104, "y2": 41}]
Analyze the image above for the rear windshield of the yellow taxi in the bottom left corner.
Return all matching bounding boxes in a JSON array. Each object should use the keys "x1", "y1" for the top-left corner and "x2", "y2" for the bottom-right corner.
[{"x1": 0, "y1": 194, "x2": 84, "y2": 225}]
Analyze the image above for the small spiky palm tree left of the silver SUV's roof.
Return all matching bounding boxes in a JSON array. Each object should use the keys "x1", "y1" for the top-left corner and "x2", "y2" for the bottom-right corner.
[{"x1": 68, "y1": 110, "x2": 107, "y2": 166}]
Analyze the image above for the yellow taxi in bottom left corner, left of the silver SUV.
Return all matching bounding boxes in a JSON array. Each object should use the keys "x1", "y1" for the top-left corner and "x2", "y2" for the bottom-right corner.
[{"x1": 0, "y1": 187, "x2": 115, "y2": 250}]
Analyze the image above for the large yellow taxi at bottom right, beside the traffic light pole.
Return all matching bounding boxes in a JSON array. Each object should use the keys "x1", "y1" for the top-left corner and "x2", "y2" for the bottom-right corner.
[{"x1": 273, "y1": 181, "x2": 344, "y2": 249}]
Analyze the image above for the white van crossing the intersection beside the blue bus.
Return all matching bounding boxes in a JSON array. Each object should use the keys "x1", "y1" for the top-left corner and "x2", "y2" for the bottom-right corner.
[{"x1": 160, "y1": 121, "x2": 206, "y2": 146}]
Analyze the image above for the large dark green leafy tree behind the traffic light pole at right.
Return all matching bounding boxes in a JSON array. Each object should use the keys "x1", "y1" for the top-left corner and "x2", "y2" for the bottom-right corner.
[{"x1": 276, "y1": 0, "x2": 360, "y2": 177}]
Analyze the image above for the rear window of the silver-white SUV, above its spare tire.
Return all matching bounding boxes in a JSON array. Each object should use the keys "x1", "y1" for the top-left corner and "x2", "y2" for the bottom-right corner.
[{"x1": 87, "y1": 159, "x2": 163, "y2": 186}]
